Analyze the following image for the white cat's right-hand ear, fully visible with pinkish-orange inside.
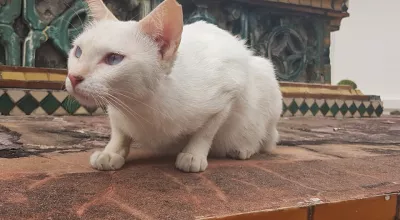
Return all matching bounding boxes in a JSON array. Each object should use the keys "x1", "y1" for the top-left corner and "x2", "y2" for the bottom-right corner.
[{"x1": 139, "y1": 0, "x2": 183, "y2": 61}]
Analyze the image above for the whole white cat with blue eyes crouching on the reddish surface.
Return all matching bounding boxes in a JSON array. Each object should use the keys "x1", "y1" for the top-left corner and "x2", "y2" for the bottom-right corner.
[{"x1": 66, "y1": 0, "x2": 282, "y2": 172}]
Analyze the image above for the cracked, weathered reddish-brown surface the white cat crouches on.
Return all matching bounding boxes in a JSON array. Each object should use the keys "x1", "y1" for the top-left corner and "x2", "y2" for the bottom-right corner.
[{"x1": 0, "y1": 116, "x2": 400, "y2": 219}]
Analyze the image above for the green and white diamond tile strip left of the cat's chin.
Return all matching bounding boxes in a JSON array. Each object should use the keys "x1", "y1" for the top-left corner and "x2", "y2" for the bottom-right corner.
[{"x1": 0, "y1": 89, "x2": 105, "y2": 116}]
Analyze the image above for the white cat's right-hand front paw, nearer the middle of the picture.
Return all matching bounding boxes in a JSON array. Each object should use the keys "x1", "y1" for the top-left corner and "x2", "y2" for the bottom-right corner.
[{"x1": 175, "y1": 153, "x2": 208, "y2": 173}]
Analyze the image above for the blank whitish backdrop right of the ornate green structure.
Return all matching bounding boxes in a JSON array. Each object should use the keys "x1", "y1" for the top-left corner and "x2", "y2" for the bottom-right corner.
[{"x1": 331, "y1": 0, "x2": 400, "y2": 109}]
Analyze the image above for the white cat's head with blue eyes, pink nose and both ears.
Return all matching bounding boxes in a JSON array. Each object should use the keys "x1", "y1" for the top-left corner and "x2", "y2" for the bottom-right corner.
[{"x1": 65, "y1": 0, "x2": 183, "y2": 106}]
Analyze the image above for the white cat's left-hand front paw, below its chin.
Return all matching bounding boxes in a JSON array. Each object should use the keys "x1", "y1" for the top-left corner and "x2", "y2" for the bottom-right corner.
[{"x1": 90, "y1": 151, "x2": 125, "y2": 170}]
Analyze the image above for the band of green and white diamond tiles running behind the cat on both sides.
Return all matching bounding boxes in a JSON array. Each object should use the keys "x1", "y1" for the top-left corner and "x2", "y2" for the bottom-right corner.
[{"x1": 0, "y1": 89, "x2": 383, "y2": 118}]
